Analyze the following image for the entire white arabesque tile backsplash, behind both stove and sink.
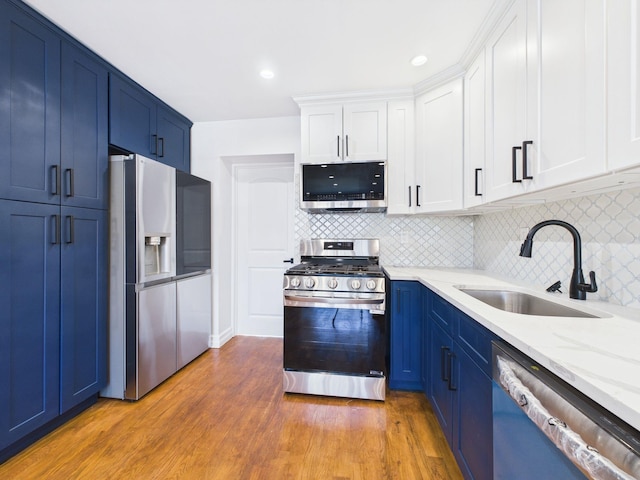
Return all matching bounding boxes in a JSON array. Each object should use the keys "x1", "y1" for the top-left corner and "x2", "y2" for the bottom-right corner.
[{"x1": 295, "y1": 188, "x2": 640, "y2": 308}]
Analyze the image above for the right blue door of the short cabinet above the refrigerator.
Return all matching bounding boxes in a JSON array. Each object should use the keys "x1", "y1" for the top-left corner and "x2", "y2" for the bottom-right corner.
[{"x1": 158, "y1": 106, "x2": 191, "y2": 172}]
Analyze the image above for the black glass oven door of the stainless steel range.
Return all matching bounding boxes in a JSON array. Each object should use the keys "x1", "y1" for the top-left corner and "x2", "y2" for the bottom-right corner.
[{"x1": 284, "y1": 297, "x2": 387, "y2": 377}]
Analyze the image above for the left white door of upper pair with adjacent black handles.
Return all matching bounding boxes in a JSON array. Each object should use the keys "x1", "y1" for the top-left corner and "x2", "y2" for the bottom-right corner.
[{"x1": 485, "y1": 0, "x2": 533, "y2": 201}]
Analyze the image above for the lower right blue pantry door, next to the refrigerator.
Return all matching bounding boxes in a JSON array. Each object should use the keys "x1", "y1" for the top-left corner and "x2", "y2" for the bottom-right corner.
[{"x1": 60, "y1": 207, "x2": 108, "y2": 413}]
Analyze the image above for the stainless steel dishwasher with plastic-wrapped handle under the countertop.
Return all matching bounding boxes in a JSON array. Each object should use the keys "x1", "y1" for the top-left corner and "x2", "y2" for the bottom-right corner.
[{"x1": 493, "y1": 342, "x2": 640, "y2": 480}]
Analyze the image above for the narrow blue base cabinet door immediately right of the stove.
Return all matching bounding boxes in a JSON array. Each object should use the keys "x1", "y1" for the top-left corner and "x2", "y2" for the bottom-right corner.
[{"x1": 389, "y1": 281, "x2": 422, "y2": 390}]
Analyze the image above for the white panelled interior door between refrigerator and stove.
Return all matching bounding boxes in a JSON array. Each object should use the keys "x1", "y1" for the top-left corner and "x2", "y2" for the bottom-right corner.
[{"x1": 234, "y1": 161, "x2": 294, "y2": 336}]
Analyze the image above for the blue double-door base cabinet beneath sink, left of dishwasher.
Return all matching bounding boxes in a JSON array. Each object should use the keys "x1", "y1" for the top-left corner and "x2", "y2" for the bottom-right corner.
[{"x1": 425, "y1": 286, "x2": 495, "y2": 480}]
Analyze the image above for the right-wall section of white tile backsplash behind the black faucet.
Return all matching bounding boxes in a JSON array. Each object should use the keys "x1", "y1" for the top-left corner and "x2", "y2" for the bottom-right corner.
[{"x1": 473, "y1": 188, "x2": 640, "y2": 308}]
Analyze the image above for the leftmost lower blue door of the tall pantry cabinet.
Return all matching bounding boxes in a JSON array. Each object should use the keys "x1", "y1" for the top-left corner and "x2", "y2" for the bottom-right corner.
[{"x1": 0, "y1": 200, "x2": 61, "y2": 450}]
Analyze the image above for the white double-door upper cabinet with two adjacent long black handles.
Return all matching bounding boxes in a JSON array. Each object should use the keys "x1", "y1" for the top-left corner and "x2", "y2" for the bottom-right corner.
[{"x1": 485, "y1": 0, "x2": 606, "y2": 201}]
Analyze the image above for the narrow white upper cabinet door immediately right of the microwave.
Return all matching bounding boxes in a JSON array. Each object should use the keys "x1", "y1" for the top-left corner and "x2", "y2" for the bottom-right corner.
[{"x1": 387, "y1": 100, "x2": 416, "y2": 215}]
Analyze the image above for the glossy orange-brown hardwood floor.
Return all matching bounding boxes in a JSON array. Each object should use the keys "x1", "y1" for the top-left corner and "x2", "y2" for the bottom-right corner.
[{"x1": 0, "y1": 337, "x2": 462, "y2": 480}]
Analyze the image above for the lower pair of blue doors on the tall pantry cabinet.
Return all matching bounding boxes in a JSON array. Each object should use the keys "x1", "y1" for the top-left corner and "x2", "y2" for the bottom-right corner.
[{"x1": 0, "y1": 200, "x2": 108, "y2": 462}]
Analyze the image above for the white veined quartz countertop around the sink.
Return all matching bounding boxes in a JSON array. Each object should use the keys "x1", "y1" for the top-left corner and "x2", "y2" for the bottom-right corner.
[{"x1": 384, "y1": 266, "x2": 640, "y2": 430}]
